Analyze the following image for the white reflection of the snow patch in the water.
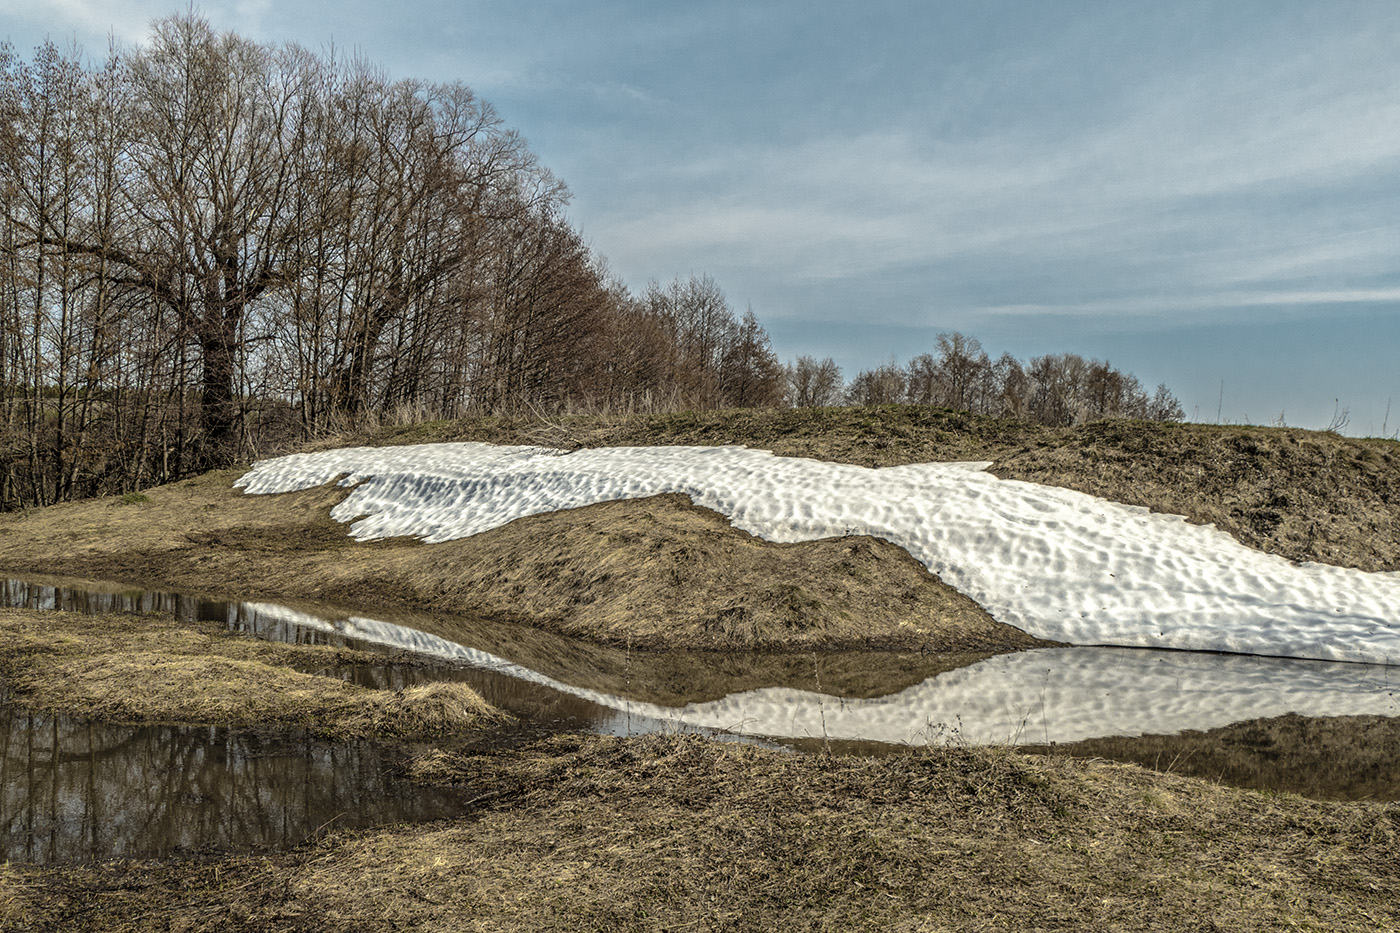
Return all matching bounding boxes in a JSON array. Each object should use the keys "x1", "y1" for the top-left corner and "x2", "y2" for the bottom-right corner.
[{"x1": 245, "y1": 604, "x2": 1400, "y2": 744}]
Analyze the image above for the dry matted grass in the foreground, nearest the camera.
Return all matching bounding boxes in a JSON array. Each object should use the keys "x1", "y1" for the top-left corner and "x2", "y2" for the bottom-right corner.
[{"x1": 10, "y1": 737, "x2": 1400, "y2": 930}]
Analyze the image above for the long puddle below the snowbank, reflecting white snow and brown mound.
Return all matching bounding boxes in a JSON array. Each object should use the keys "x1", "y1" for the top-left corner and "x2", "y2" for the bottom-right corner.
[{"x1": 0, "y1": 580, "x2": 1400, "y2": 799}]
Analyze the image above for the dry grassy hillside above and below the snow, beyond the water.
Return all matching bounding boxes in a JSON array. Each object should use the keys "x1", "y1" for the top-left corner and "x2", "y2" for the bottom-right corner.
[{"x1": 0, "y1": 406, "x2": 1400, "y2": 653}]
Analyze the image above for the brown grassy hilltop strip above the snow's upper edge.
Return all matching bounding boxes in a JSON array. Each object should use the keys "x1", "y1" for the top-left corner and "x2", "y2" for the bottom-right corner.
[{"x1": 341, "y1": 405, "x2": 1400, "y2": 570}]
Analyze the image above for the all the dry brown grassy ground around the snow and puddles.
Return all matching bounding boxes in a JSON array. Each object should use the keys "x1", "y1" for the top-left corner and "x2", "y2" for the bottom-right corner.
[{"x1": 0, "y1": 408, "x2": 1400, "y2": 930}]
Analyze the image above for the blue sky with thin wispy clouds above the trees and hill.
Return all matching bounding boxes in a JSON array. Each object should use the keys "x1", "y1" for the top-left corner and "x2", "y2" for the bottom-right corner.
[{"x1": 0, "y1": 0, "x2": 1400, "y2": 437}]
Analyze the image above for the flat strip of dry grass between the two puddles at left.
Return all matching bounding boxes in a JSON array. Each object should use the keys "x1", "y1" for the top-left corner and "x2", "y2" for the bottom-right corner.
[{"x1": 0, "y1": 609, "x2": 505, "y2": 738}]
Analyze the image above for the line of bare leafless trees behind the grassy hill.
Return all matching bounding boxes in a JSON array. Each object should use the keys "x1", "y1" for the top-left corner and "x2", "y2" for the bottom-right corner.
[{"x1": 0, "y1": 14, "x2": 1180, "y2": 509}]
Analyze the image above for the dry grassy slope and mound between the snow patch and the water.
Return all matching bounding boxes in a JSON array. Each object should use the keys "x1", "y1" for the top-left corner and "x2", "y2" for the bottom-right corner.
[{"x1": 0, "y1": 474, "x2": 1044, "y2": 653}]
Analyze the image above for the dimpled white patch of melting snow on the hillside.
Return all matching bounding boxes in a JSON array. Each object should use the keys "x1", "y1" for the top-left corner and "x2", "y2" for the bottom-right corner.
[{"x1": 238, "y1": 444, "x2": 1400, "y2": 663}]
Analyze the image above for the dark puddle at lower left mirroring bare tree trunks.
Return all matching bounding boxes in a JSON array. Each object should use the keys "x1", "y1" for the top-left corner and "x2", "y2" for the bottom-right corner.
[{"x1": 0, "y1": 707, "x2": 461, "y2": 863}]
